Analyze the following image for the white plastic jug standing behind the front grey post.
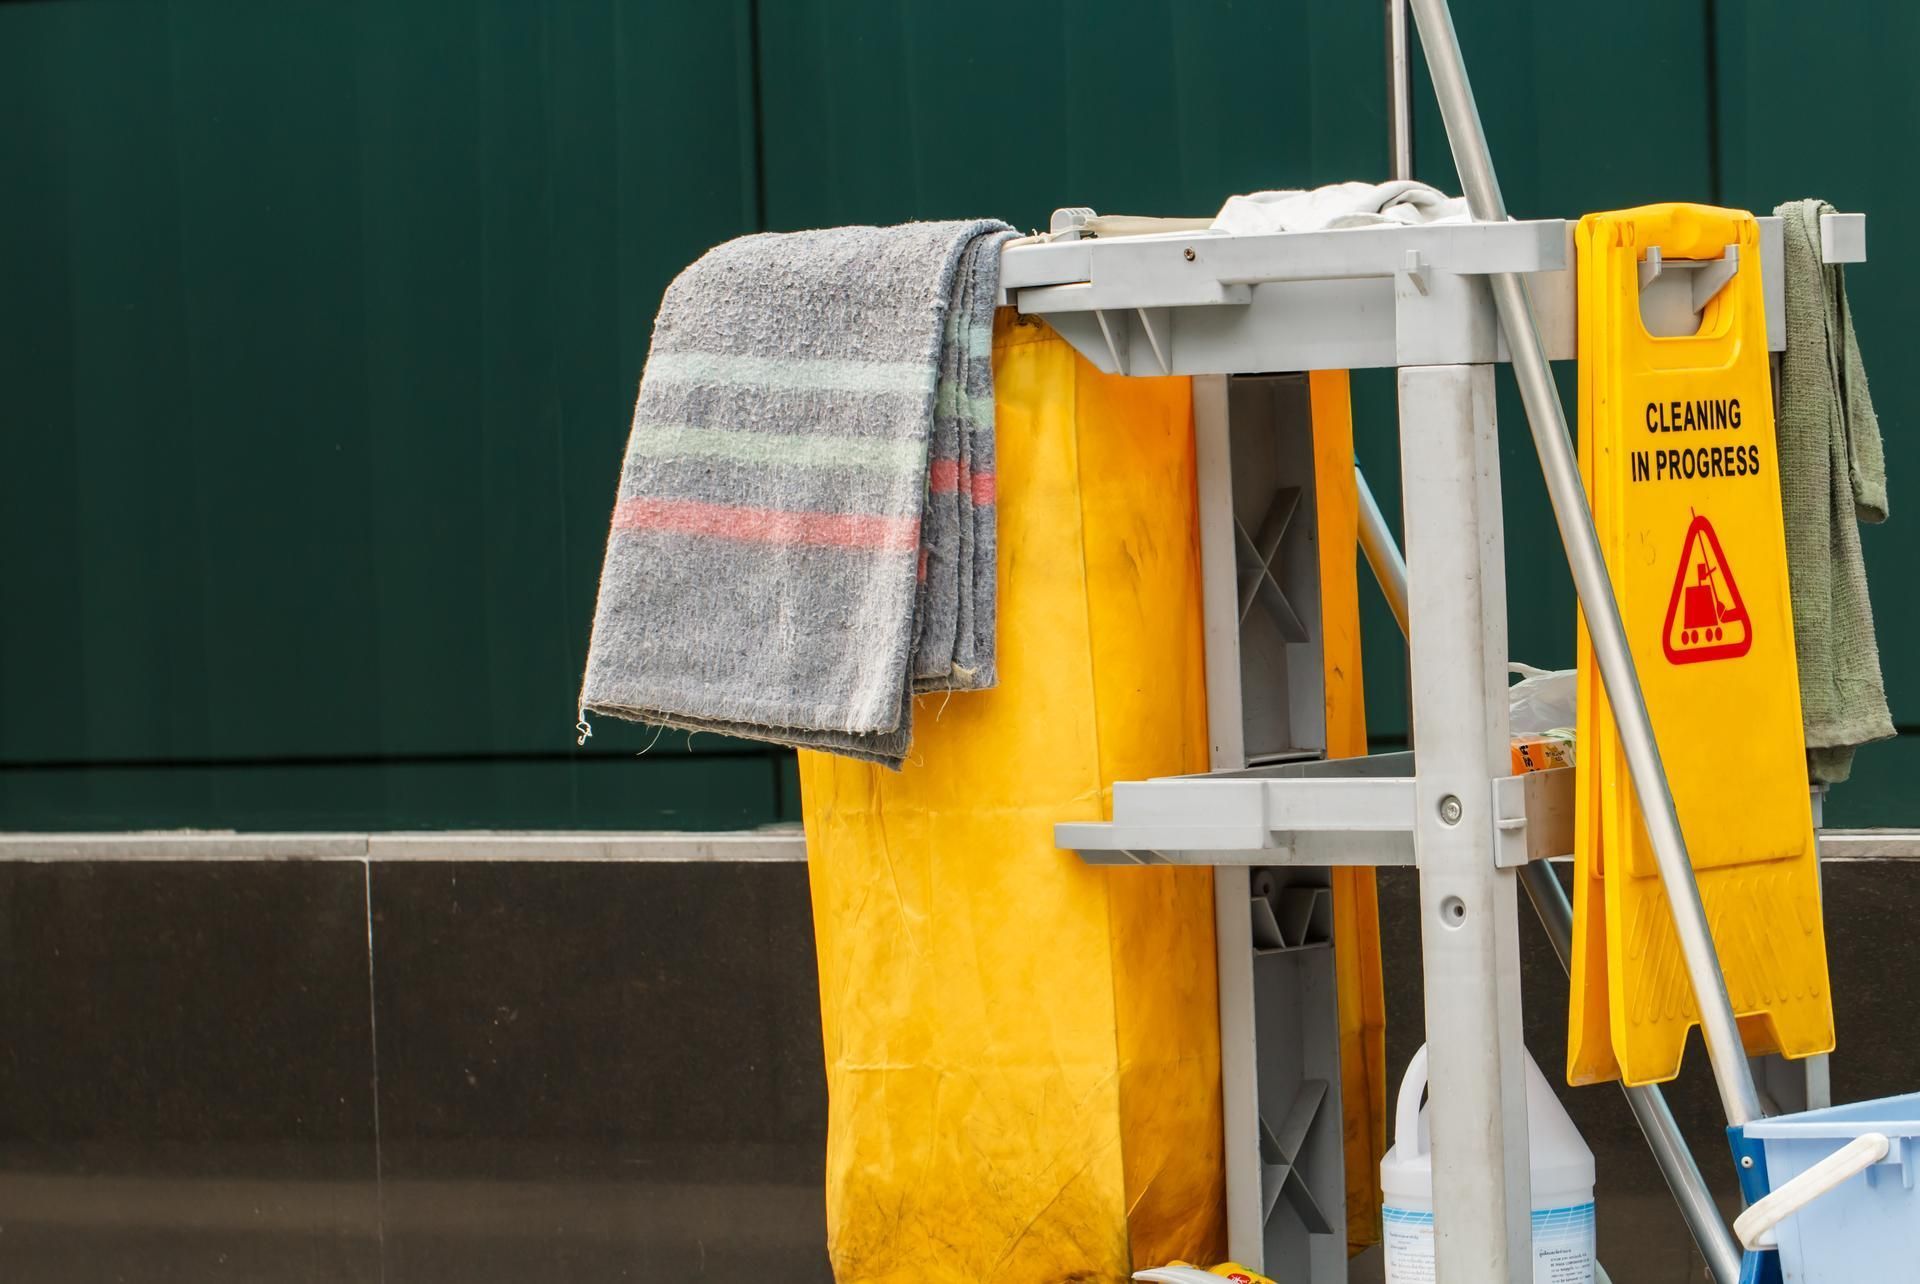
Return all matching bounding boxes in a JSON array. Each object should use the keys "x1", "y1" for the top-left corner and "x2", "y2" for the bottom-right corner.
[{"x1": 1380, "y1": 1046, "x2": 1594, "y2": 1284}]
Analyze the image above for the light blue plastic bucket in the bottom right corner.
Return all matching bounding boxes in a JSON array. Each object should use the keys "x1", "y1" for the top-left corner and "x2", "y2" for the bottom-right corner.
[{"x1": 1745, "y1": 1092, "x2": 1920, "y2": 1284}]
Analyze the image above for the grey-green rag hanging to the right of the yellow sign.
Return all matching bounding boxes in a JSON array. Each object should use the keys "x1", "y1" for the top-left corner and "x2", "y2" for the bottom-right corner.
[{"x1": 1774, "y1": 200, "x2": 1893, "y2": 783}]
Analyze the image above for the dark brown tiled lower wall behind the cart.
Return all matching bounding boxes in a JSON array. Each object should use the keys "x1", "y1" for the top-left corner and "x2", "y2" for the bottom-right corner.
[{"x1": 0, "y1": 862, "x2": 1920, "y2": 1284}]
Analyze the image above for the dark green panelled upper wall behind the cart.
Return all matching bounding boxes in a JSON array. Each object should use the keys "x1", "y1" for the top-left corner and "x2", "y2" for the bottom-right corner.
[{"x1": 0, "y1": 0, "x2": 1920, "y2": 829}]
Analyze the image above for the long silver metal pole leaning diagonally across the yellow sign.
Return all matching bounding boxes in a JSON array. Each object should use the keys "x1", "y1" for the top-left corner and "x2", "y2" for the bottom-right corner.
[{"x1": 1411, "y1": 0, "x2": 1761, "y2": 1125}]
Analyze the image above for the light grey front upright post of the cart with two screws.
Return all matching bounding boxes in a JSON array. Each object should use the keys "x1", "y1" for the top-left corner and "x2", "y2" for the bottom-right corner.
[{"x1": 1400, "y1": 367, "x2": 1534, "y2": 1284}]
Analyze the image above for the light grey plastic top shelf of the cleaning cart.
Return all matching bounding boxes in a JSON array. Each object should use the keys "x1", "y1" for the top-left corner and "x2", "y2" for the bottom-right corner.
[{"x1": 1000, "y1": 209, "x2": 1866, "y2": 364}]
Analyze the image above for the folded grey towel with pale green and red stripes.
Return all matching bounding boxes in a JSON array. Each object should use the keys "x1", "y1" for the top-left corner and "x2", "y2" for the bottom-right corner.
[{"x1": 580, "y1": 221, "x2": 1012, "y2": 766}]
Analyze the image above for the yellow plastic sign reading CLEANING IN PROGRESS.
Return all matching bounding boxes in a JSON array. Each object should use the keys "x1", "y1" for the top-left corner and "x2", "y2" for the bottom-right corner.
[{"x1": 1567, "y1": 205, "x2": 1834, "y2": 1084}]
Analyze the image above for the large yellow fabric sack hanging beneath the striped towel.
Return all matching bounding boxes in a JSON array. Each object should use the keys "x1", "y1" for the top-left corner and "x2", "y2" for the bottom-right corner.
[{"x1": 801, "y1": 313, "x2": 1225, "y2": 1284}]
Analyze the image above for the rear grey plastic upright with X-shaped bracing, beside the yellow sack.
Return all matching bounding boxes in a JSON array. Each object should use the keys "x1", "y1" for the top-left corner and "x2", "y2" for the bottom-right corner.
[{"x1": 1190, "y1": 368, "x2": 1344, "y2": 1284}]
